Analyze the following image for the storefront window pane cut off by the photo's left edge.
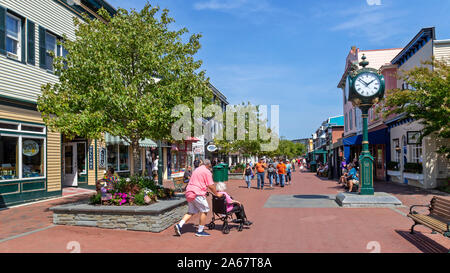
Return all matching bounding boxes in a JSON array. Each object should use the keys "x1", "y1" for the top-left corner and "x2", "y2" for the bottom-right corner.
[{"x1": 0, "y1": 136, "x2": 19, "y2": 180}]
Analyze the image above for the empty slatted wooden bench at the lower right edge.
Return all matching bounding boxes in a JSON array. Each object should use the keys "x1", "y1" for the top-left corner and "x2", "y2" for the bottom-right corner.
[{"x1": 408, "y1": 196, "x2": 450, "y2": 237}]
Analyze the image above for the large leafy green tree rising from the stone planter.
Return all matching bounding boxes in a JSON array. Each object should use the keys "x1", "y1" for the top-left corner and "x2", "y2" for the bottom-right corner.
[{"x1": 38, "y1": 3, "x2": 211, "y2": 173}]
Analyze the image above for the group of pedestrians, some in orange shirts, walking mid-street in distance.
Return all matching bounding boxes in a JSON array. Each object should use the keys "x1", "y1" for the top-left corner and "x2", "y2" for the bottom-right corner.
[{"x1": 242, "y1": 158, "x2": 302, "y2": 190}]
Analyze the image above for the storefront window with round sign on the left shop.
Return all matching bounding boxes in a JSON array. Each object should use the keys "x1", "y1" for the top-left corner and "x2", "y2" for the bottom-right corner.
[{"x1": 22, "y1": 138, "x2": 44, "y2": 178}]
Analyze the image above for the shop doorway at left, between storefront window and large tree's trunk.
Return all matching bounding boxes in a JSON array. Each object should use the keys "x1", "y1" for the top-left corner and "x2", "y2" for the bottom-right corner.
[{"x1": 63, "y1": 142, "x2": 86, "y2": 187}]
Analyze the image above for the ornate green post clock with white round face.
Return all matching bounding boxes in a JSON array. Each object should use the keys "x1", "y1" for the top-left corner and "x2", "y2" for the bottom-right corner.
[{"x1": 346, "y1": 55, "x2": 385, "y2": 195}]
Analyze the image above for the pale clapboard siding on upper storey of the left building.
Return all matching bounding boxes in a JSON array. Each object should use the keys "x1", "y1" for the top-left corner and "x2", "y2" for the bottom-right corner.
[{"x1": 0, "y1": 0, "x2": 76, "y2": 102}]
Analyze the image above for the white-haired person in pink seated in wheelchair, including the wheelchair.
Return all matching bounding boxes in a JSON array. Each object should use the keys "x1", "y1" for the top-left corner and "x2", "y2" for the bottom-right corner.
[{"x1": 207, "y1": 182, "x2": 253, "y2": 234}]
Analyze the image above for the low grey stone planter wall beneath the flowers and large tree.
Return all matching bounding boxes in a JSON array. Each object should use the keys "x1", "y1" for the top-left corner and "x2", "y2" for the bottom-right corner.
[{"x1": 50, "y1": 197, "x2": 187, "y2": 232}]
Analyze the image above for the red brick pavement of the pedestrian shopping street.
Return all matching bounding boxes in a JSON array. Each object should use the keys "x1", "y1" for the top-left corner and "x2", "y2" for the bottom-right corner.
[{"x1": 0, "y1": 172, "x2": 450, "y2": 253}]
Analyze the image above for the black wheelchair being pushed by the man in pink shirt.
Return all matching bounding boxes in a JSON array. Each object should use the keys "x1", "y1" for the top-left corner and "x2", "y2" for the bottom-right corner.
[{"x1": 206, "y1": 193, "x2": 244, "y2": 234}]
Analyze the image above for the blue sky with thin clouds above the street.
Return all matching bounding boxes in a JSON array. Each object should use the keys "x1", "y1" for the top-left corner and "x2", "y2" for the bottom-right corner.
[{"x1": 104, "y1": 0, "x2": 450, "y2": 139}]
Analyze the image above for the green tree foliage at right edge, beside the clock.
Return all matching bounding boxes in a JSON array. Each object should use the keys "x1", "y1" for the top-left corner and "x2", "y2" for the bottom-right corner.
[{"x1": 385, "y1": 59, "x2": 450, "y2": 158}]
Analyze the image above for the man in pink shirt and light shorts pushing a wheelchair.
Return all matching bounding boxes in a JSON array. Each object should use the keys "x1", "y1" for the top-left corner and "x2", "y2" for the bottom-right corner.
[{"x1": 174, "y1": 159, "x2": 222, "y2": 237}]
